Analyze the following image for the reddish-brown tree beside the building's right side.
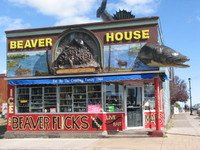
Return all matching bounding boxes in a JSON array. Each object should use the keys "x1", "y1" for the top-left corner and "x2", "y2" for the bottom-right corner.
[{"x1": 170, "y1": 76, "x2": 189, "y2": 104}]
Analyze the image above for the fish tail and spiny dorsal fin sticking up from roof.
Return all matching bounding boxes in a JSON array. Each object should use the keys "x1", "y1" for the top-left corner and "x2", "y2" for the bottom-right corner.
[{"x1": 96, "y1": 0, "x2": 135, "y2": 21}]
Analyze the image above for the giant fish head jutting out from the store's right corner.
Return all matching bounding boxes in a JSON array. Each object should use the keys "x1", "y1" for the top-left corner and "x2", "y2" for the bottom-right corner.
[{"x1": 137, "y1": 44, "x2": 190, "y2": 68}]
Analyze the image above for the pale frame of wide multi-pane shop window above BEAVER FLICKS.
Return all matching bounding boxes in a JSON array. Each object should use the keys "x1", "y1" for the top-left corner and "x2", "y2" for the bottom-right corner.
[{"x1": 15, "y1": 83, "x2": 103, "y2": 114}]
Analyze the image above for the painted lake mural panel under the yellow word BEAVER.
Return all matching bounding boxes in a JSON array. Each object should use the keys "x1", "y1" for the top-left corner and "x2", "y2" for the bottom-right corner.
[{"x1": 7, "y1": 50, "x2": 49, "y2": 77}]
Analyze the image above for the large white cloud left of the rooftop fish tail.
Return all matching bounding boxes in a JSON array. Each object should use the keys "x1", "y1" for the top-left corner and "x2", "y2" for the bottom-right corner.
[{"x1": 9, "y1": 0, "x2": 98, "y2": 25}]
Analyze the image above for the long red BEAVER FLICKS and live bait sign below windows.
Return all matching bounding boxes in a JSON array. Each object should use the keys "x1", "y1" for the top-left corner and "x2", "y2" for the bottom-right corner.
[{"x1": 7, "y1": 113, "x2": 124, "y2": 131}]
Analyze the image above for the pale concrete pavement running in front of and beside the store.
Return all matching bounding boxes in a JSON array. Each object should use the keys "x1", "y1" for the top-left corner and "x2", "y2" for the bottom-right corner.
[{"x1": 0, "y1": 113, "x2": 200, "y2": 150}]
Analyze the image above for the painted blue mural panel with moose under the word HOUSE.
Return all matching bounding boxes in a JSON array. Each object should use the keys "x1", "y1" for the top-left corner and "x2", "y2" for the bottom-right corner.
[{"x1": 104, "y1": 43, "x2": 158, "y2": 72}]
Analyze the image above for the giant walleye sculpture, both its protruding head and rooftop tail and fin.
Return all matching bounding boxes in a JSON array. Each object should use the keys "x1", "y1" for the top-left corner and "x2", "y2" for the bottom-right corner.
[{"x1": 96, "y1": 0, "x2": 189, "y2": 68}]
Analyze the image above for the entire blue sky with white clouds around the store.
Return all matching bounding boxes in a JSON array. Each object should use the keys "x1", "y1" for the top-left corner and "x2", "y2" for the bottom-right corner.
[{"x1": 0, "y1": 0, "x2": 200, "y2": 104}]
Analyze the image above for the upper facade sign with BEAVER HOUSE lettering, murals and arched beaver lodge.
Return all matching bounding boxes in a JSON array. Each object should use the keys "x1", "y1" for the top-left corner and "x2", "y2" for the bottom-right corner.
[{"x1": 7, "y1": 27, "x2": 158, "y2": 77}]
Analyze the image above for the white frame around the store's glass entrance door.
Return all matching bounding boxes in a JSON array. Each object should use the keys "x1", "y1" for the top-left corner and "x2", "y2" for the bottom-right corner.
[{"x1": 124, "y1": 85, "x2": 145, "y2": 130}]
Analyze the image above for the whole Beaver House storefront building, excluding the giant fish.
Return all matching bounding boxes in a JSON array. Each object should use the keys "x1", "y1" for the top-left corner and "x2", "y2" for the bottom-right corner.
[{"x1": 6, "y1": 17, "x2": 169, "y2": 135}]
